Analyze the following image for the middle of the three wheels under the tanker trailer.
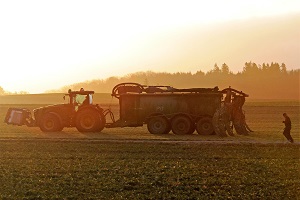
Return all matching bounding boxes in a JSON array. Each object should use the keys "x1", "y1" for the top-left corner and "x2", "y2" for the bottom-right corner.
[{"x1": 171, "y1": 116, "x2": 193, "y2": 135}]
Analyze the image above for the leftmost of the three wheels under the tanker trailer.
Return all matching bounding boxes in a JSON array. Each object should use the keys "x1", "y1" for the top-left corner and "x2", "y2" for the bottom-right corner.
[{"x1": 147, "y1": 116, "x2": 171, "y2": 134}]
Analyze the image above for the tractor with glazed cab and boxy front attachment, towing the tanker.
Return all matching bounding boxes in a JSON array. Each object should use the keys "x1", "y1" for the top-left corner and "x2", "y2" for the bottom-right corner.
[{"x1": 4, "y1": 89, "x2": 106, "y2": 132}]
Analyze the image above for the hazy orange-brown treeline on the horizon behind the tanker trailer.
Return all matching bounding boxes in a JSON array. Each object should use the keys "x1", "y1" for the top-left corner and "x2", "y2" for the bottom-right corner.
[{"x1": 55, "y1": 62, "x2": 300, "y2": 100}]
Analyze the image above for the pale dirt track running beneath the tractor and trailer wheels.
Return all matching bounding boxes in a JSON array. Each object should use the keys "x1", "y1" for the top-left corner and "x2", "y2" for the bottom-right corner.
[{"x1": 0, "y1": 126, "x2": 300, "y2": 145}]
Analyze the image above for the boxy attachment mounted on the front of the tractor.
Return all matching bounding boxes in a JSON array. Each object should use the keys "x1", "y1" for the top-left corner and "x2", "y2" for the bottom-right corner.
[{"x1": 4, "y1": 108, "x2": 32, "y2": 126}]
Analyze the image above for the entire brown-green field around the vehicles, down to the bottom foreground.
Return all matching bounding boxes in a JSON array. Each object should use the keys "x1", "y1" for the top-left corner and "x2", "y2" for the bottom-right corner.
[{"x1": 0, "y1": 101, "x2": 300, "y2": 199}]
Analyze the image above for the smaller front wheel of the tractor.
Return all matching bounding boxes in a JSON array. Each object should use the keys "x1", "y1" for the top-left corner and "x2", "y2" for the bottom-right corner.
[{"x1": 39, "y1": 113, "x2": 63, "y2": 132}]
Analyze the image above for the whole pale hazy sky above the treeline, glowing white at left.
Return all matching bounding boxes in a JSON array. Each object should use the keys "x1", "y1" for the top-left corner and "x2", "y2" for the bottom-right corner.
[{"x1": 0, "y1": 0, "x2": 300, "y2": 93}]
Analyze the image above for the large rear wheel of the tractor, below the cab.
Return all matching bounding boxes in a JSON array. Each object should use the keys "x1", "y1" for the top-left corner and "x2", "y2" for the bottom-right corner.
[{"x1": 76, "y1": 110, "x2": 105, "y2": 132}]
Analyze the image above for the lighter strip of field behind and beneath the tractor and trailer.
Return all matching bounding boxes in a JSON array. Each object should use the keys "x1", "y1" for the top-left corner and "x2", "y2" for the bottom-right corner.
[{"x1": 0, "y1": 101, "x2": 300, "y2": 145}]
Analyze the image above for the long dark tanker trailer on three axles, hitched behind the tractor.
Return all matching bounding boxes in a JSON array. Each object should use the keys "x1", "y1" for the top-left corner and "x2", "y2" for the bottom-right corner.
[{"x1": 106, "y1": 83, "x2": 248, "y2": 136}]
